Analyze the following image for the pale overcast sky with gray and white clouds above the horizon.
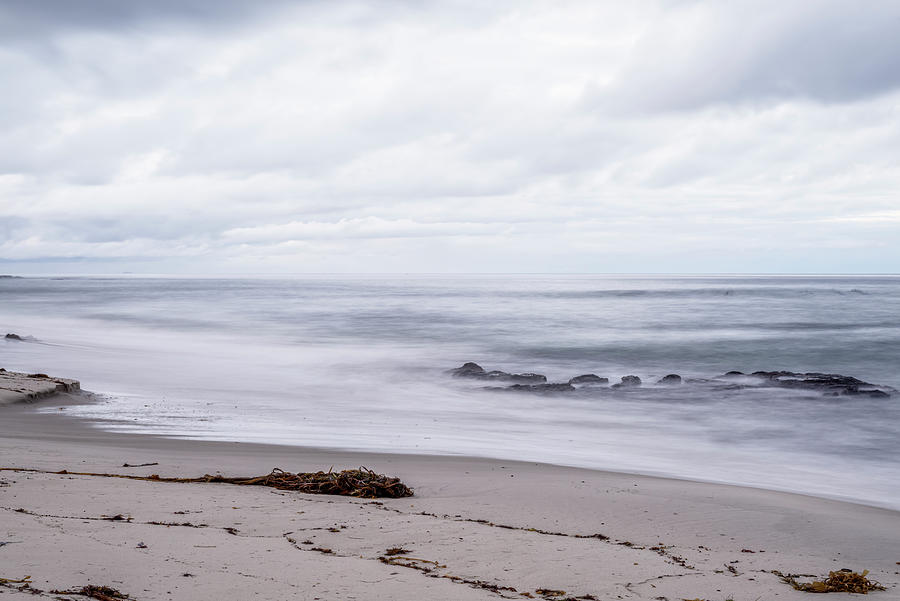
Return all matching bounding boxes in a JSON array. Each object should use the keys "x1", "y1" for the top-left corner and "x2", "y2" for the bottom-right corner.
[{"x1": 0, "y1": 0, "x2": 900, "y2": 273}]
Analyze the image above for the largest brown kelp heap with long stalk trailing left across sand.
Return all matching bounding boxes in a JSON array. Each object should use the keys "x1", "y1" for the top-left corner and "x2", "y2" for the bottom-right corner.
[{"x1": 0, "y1": 467, "x2": 413, "y2": 499}]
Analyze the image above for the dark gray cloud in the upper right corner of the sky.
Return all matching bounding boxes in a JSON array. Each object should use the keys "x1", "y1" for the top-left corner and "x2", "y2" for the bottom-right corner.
[{"x1": 591, "y1": 0, "x2": 900, "y2": 111}]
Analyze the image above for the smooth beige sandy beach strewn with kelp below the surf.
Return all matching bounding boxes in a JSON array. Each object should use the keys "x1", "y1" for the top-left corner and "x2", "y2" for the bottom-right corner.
[{"x1": 0, "y1": 386, "x2": 900, "y2": 601}]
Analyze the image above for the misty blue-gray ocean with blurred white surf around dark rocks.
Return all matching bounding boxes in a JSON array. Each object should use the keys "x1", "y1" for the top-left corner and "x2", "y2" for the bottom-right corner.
[{"x1": 0, "y1": 275, "x2": 900, "y2": 509}]
